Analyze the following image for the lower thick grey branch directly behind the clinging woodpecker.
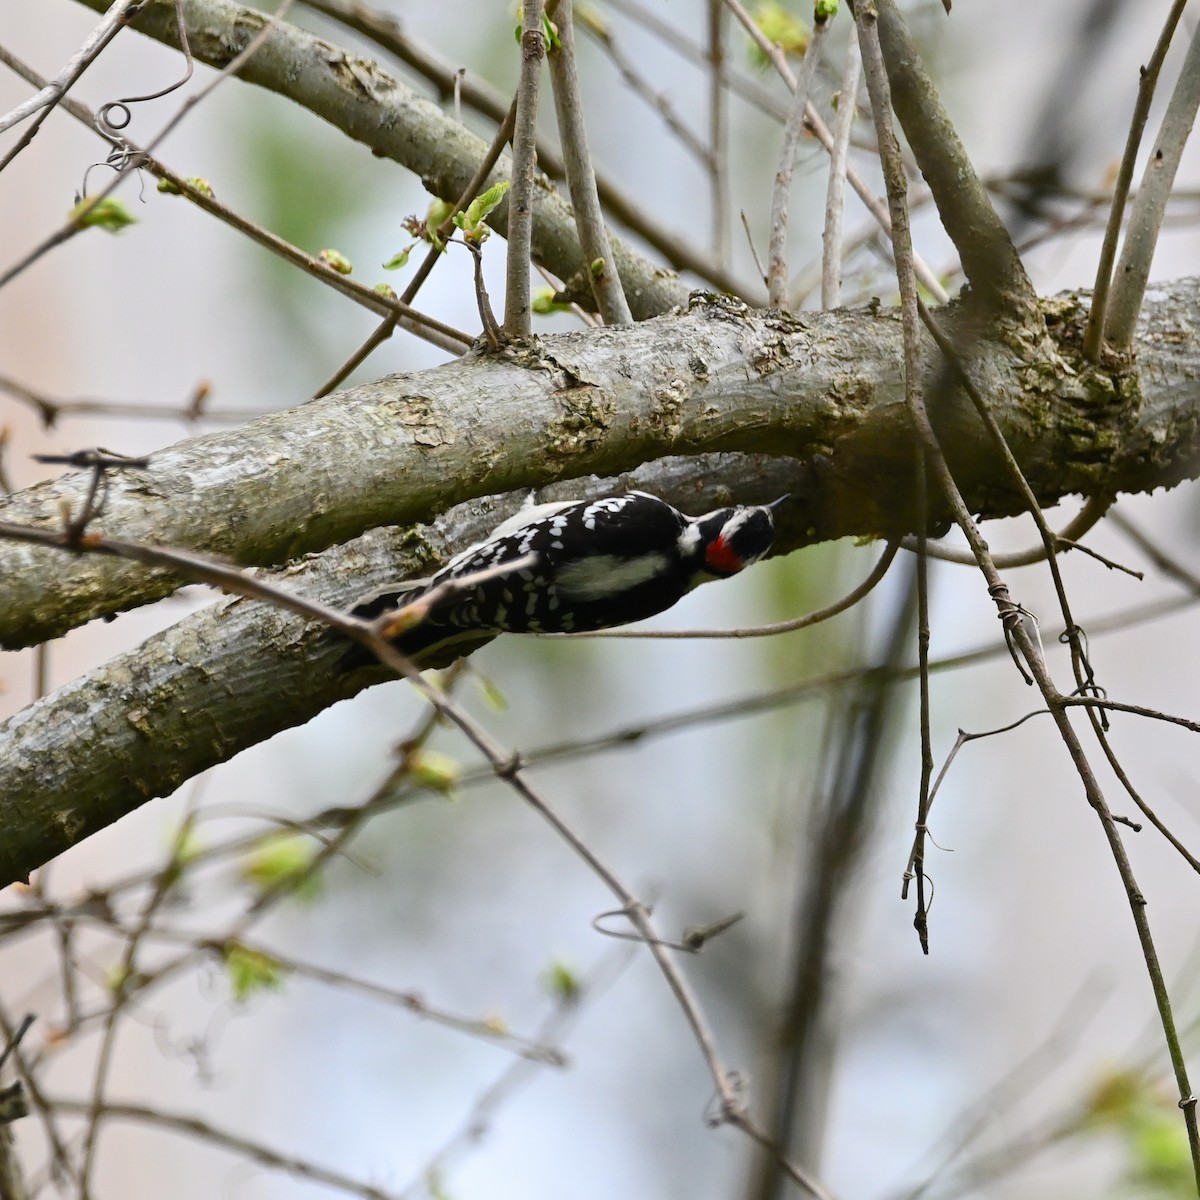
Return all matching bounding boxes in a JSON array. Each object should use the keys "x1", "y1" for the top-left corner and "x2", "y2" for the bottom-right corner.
[{"x1": 0, "y1": 456, "x2": 790, "y2": 889}]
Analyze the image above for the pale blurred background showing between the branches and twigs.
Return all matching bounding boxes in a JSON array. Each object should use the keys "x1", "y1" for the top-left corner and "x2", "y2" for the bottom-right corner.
[{"x1": 0, "y1": 0, "x2": 1200, "y2": 1200}]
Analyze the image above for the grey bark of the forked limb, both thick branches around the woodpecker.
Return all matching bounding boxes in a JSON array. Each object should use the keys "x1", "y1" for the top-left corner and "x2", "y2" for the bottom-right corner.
[{"x1": 0, "y1": 280, "x2": 1200, "y2": 886}]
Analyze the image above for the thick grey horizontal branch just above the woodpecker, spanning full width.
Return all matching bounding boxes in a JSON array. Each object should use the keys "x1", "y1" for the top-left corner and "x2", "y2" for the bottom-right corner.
[{"x1": 0, "y1": 280, "x2": 1200, "y2": 649}]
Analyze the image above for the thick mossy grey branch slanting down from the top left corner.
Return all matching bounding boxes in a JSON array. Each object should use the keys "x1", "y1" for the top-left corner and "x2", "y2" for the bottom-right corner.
[{"x1": 70, "y1": 0, "x2": 688, "y2": 320}]
